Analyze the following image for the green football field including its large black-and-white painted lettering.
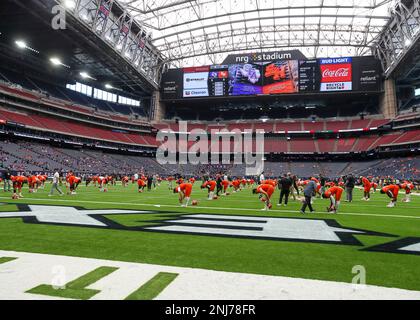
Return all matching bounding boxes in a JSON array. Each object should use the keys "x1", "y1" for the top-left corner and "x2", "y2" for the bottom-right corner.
[{"x1": 0, "y1": 183, "x2": 420, "y2": 298}]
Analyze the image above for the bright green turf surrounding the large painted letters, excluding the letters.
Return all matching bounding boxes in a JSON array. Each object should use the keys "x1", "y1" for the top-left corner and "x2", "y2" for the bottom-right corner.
[{"x1": 0, "y1": 180, "x2": 420, "y2": 290}]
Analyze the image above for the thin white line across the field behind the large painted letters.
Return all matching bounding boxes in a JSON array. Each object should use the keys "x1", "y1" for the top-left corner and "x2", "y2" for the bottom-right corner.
[{"x1": 0, "y1": 197, "x2": 420, "y2": 219}]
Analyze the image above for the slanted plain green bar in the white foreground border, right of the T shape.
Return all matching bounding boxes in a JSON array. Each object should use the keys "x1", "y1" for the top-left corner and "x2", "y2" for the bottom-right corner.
[{"x1": 125, "y1": 272, "x2": 178, "y2": 300}]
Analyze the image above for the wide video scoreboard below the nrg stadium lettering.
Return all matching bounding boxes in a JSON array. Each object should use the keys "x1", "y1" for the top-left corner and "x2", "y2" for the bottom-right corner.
[{"x1": 161, "y1": 55, "x2": 382, "y2": 100}]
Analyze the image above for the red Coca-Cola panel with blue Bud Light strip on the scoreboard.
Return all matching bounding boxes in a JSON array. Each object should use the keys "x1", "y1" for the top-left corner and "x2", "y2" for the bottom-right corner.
[{"x1": 320, "y1": 58, "x2": 353, "y2": 92}]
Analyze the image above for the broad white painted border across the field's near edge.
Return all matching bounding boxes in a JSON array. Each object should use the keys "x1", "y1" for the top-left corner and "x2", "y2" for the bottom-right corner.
[{"x1": 0, "y1": 250, "x2": 420, "y2": 300}]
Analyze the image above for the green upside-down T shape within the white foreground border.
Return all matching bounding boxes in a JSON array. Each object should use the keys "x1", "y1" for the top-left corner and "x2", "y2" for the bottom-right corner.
[{"x1": 27, "y1": 267, "x2": 118, "y2": 300}]
